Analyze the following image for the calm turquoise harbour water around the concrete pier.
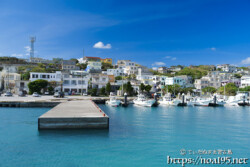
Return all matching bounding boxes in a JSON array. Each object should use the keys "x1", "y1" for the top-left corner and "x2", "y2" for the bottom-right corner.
[{"x1": 0, "y1": 105, "x2": 250, "y2": 167}]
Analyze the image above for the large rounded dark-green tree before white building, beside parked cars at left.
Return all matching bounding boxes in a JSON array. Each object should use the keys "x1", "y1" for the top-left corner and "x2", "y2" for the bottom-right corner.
[{"x1": 28, "y1": 79, "x2": 48, "y2": 94}]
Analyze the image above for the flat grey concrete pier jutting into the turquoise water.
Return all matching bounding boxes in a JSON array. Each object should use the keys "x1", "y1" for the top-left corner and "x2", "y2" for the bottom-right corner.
[{"x1": 38, "y1": 100, "x2": 109, "y2": 130}]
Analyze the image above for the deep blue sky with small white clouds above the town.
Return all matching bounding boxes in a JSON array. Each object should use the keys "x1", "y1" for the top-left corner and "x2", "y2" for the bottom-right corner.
[{"x1": 0, "y1": 0, "x2": 250, "y2": 67}]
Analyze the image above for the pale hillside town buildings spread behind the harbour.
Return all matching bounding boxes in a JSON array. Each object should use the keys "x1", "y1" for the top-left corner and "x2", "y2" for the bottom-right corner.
[{"x1": 0, "y1": 56, "x2": 250, "y2": 94}]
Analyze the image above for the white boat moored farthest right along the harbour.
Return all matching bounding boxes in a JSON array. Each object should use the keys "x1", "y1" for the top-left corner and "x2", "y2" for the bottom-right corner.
[{"x1": 226, "y1": 92, "x2": 248, "y2": 106}]
